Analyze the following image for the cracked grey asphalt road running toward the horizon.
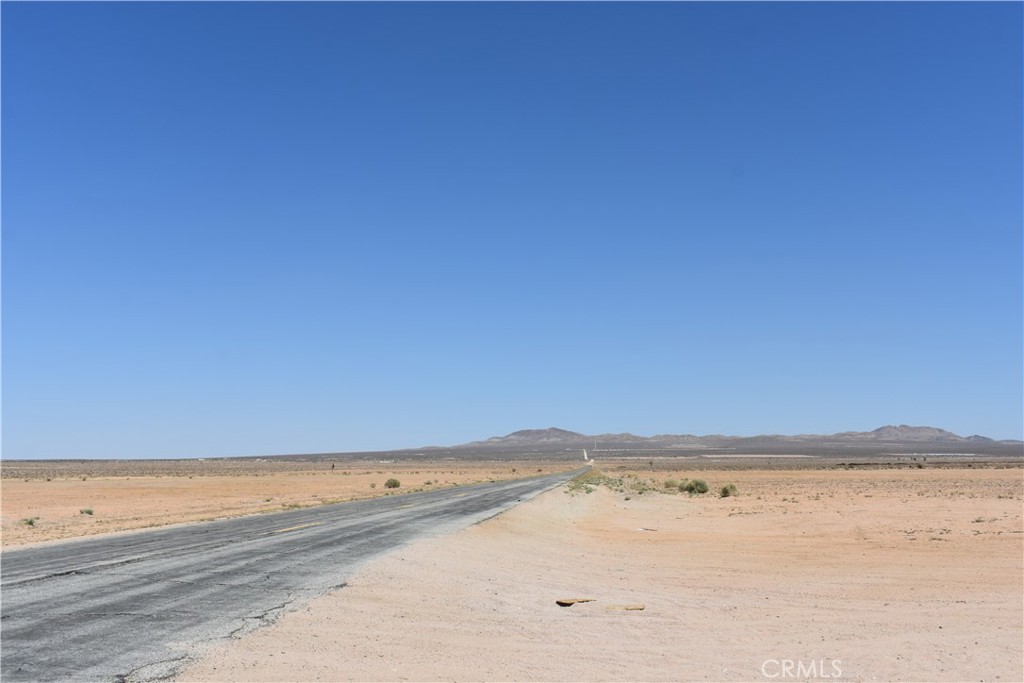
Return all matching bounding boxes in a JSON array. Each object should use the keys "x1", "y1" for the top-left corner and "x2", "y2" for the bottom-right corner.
[{"x1": 0, "y1": 471, "x2": 580, "y2": 683}]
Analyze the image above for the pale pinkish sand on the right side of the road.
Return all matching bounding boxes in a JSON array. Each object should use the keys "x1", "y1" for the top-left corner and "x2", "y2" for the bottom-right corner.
[{"x1": 179, "y1": 470, "x2": 1024, "y2": 681}]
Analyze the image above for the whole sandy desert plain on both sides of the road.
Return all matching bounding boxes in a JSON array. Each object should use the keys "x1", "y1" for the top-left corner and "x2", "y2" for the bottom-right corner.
[{"x1": 2, "y1": 459, "x2": 1024, "y2": 681}]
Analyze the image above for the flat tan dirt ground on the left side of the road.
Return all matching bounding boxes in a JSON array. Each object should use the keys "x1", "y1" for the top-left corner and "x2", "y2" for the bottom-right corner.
[{"x1": 0, "y1": 460, "x2": 579, "y2": 548}]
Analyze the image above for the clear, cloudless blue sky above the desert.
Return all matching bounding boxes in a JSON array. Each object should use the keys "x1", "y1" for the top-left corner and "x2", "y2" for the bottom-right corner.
[{"x1": 2, "y1": 2, "x2": 1024, "y2": 458}]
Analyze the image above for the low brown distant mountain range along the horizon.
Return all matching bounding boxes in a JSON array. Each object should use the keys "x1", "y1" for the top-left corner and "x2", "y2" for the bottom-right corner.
[{"x1": 453, "y1": 425, "x2": 1024, "y2": 453}]
